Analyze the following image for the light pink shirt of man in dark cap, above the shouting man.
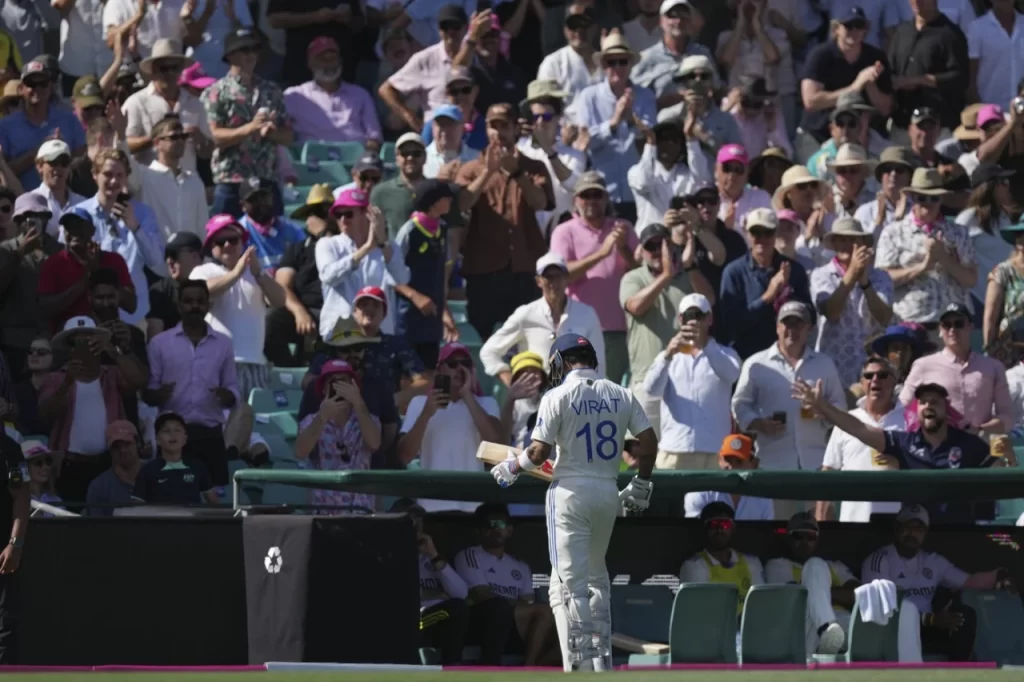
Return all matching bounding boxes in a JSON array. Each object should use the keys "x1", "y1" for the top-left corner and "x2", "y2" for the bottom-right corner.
[{"x1": 899, "y1": 348, "x2": 1014, "y2": 431}]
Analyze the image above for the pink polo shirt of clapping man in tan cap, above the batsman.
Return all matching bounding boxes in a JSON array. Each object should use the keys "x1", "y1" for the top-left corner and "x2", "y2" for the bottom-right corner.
[{"x1": 551, "y1": 217, "x2": 638, "y2": 332}]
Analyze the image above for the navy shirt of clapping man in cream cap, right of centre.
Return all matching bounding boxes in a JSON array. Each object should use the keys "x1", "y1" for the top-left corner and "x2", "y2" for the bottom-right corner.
[{"x1": 716, "y1": 251, "x2": 811, "y2": 359}]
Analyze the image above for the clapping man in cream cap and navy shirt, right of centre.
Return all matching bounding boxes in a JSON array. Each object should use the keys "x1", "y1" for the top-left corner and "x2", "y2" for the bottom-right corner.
[{"x1": 719, "y1": 209, "x2": 811, "y2": 356}]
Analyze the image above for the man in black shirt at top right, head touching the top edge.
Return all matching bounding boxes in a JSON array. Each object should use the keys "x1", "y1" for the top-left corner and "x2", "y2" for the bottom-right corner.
[{"x1": 880, "y1": 0, "x2": 966, "y2": 144}]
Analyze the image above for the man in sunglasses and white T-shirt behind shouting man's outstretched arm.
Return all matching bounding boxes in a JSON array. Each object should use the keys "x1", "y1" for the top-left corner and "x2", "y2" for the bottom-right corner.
[{"x1": 815, "y1": 355, "x2": 904, "y2": 523}]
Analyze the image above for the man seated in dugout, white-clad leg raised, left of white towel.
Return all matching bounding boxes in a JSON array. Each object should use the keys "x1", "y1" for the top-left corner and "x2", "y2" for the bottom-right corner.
[{"x1": 765, "y1": 512, "x2": 860, "y2": 655}]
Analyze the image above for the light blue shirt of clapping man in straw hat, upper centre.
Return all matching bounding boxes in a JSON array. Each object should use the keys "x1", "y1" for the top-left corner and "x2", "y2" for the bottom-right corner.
[{"x1": 572, "y1": 81, "x2": 657, "y2": 204}]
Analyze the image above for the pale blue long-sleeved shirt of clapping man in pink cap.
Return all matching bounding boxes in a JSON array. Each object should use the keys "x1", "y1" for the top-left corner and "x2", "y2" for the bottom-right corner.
[{"x1": 316, "y1": 235, "x2": 410, "y2": 339}]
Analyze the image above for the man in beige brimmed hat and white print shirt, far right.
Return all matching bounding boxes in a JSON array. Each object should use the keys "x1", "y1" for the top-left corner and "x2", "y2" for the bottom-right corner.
[{"x1": 874, "y1": 164, "x2": 978, "y2": 323}]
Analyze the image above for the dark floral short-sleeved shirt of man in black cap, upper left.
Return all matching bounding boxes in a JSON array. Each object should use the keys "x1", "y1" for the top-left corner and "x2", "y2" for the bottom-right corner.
[{"x1": 201, "y1": 74, "x2": 287, "y2": 183}]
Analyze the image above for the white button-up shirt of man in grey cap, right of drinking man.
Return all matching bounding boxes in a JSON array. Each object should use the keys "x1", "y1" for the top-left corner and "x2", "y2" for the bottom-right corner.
[{"x1": 732, "y1": 343, "x2": 846, "y2": 471}]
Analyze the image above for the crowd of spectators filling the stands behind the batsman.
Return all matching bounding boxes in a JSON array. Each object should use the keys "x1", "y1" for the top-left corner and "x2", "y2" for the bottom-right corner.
[{"x1": 0, "y1": 0, "x2": 1024, "y2": 662}]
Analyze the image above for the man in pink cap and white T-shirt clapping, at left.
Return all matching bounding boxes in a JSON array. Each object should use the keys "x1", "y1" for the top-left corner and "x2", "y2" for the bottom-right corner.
[{"x1": 190, "y1": 214, "x2": 285, "y2": 393}]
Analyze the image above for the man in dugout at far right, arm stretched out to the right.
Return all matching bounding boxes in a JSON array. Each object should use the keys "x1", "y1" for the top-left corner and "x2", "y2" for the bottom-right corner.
[{"x1": 860, "y1": 505, "x2": 1016, "y2": 660}]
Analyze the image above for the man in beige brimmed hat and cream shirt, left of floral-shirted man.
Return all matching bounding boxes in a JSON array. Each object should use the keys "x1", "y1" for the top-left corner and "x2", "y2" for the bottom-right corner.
[{"x1": 122, "y1": 39, "x2": 209, "y2": 173}]
